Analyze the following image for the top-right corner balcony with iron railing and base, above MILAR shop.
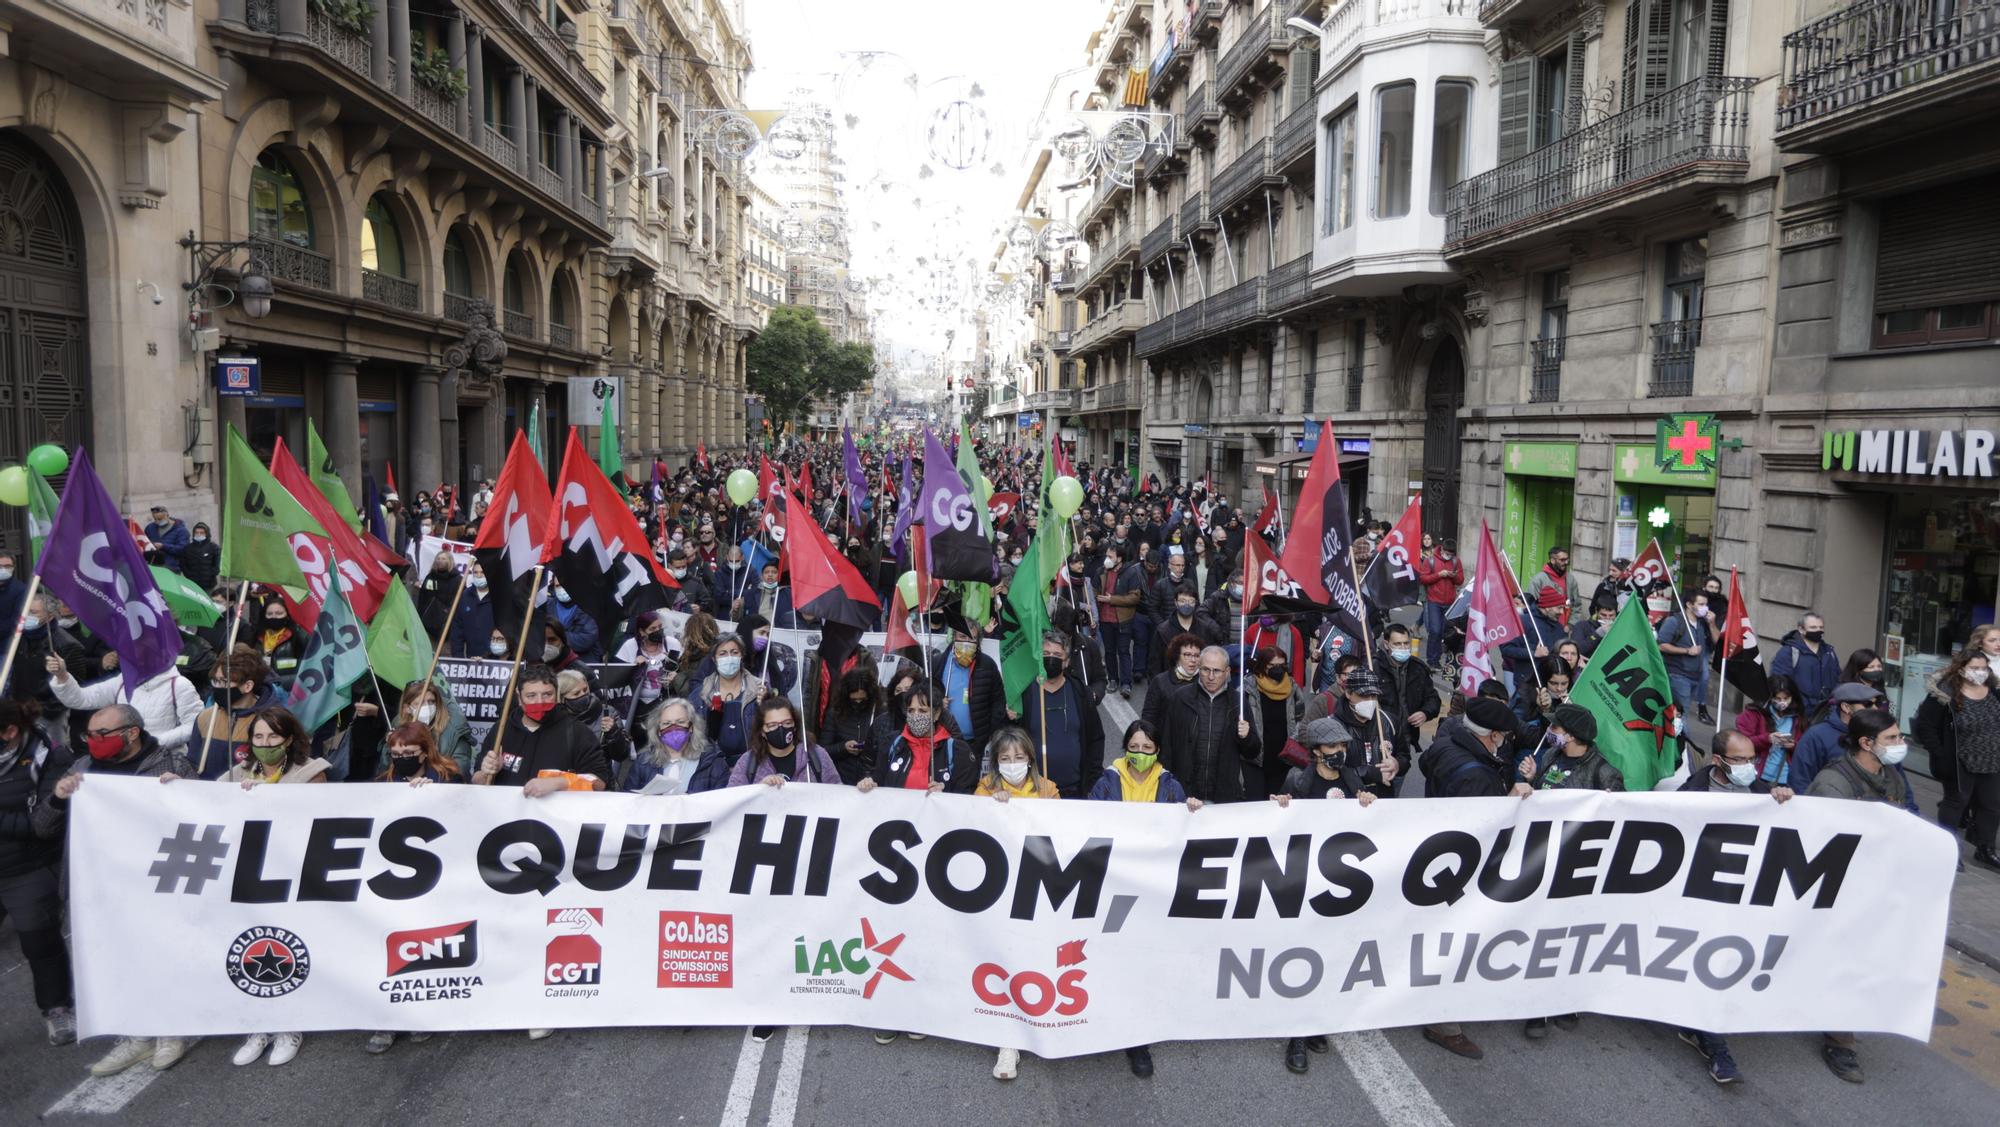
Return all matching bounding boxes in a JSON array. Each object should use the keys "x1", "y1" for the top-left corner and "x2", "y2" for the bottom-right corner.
[{"x1": 1778, "y1": 0, "x2": 2000, "y2": 152}]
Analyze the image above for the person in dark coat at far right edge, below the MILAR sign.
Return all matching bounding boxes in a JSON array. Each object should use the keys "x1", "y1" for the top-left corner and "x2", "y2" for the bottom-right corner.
[{"x1": 1912, "y1": 645, "x2": 2000, "y2": 869}]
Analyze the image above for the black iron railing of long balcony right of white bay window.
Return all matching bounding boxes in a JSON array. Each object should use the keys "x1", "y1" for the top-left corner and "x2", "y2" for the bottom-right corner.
[{"x1": 1446, "y1": 76, "x2": 1756, "y2": 242}]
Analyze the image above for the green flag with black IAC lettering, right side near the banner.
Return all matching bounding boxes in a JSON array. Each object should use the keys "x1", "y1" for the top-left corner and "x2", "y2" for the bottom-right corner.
[{"x1": 1570, "y1": 599, "x2": 1680, "y2": 791}]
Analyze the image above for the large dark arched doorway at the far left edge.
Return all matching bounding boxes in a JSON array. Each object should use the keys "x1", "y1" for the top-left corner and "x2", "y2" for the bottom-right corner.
[{"x1": 0, "y1": 132, "x2": 90, "y2": 552}]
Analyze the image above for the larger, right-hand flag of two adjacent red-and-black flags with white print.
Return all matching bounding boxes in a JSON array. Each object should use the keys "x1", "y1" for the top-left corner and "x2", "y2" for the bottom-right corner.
[{"x1": 540, "y1": 428, "x2": 680, "y2": 631}]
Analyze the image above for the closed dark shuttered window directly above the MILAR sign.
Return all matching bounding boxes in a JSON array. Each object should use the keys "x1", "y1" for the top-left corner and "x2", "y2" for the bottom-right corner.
[{"x1": 1876, "y1": 176, "x2": 2000, "y2": 314}]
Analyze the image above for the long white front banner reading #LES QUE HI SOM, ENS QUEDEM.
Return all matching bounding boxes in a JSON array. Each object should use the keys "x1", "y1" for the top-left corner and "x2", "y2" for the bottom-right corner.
[{"x1": 68, "y1": 775, "x2": 1954, "y2": 1057}]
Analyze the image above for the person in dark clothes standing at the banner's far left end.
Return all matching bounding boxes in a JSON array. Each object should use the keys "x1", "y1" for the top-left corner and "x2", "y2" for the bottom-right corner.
[{"x1": 0, "y1": 699, "x2": 76, "y2": 1045}]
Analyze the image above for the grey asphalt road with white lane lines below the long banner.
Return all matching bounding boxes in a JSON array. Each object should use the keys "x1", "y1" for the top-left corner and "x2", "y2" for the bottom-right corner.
[{"x1": 11, "y1": 679, "x2": 2000, "y2": 1127}]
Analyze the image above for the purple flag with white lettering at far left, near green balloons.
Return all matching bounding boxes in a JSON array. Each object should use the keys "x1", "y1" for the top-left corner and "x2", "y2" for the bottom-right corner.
[{"x1": 36, "y1": 448, "x2": 180, "y2": 695}]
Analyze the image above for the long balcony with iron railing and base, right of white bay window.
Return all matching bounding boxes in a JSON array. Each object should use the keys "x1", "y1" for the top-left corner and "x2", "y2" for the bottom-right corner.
[{"x1": 1446, "y1": 76, "x2": 1756, "y2": 256}]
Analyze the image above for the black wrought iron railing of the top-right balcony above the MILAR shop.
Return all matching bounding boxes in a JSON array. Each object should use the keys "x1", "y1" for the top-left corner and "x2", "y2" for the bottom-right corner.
[{"x1": 1778, "y1": 0, "x2": 2000, "y2": 130}]
